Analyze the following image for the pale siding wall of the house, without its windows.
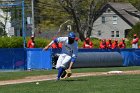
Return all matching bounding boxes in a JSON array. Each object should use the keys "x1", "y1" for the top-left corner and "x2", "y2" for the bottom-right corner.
[{"x1": 91, "y1": 8, "x2": 132, "y2": 39}]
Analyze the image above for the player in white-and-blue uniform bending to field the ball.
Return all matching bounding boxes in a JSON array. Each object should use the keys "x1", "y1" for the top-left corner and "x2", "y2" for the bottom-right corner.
[{"x1": 44, "y1": 32, "x2": 78, "y2": 80}]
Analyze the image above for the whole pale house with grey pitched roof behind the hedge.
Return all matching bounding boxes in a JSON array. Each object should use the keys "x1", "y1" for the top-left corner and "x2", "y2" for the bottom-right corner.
[{"x1": 91, "y1": 2, "x2": 140, "y2": 39}]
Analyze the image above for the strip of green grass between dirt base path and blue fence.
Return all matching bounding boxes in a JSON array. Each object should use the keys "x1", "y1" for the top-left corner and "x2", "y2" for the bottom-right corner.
[{"x1": 0, "y1": 66, "x2": 140, "y2": 81}]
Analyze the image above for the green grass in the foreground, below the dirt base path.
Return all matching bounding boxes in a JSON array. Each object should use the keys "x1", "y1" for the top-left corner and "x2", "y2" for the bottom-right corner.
[{"x1": 0, "y1": 75, "x2": 140, "y2": 93}]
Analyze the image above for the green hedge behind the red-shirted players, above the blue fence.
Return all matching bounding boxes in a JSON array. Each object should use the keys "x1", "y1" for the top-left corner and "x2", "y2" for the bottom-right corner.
[{"x1": 0, "y1": 37, "x2": 140, "y2": 48}]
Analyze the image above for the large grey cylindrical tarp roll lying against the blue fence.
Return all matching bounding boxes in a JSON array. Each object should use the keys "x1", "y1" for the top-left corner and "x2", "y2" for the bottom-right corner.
[{"x1": 73, "y1": 52, "x2": 123, "y2": 68}]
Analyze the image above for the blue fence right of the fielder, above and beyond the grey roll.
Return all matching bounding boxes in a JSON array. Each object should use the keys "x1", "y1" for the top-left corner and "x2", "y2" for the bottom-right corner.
[{"x1": 79, "y1": 48, "x2": 140, "y2": 66}]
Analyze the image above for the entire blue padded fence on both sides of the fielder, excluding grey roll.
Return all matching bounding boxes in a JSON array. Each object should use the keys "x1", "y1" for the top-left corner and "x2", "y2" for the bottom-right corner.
[{"x1": 0, "y1": 48, "x2": 140, "y2": 69}]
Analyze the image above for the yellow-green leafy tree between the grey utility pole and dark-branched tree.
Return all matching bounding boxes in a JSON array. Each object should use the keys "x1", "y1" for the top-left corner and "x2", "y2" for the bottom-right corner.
[{"x1": 35, "y1": 0, "x2": 69, "y2": 30}]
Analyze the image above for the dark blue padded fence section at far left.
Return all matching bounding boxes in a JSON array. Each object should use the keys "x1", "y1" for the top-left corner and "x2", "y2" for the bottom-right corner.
[{"x1": 0, "y1": 48, "x2": 26, "y2": 69}]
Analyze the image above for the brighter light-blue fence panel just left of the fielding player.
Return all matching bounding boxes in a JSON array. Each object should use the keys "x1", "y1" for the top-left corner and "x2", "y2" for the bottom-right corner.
[{"x1": 26, "y1": 48, "x2": 52, "y2": 69}]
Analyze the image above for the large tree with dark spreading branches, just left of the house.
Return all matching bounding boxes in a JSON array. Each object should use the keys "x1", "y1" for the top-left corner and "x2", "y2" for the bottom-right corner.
[{"x1": 59, "y1": 0, "x2": 107, "y2": 40}]
